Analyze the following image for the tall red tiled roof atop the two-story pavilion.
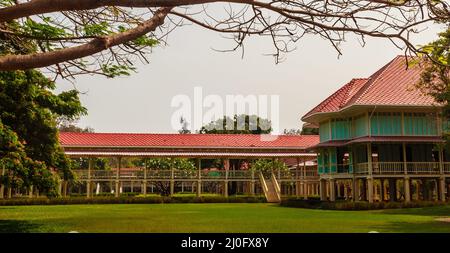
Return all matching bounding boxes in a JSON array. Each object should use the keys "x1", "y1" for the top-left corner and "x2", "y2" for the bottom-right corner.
[{"x1": 302, "y1": 56, "x2": 438, "y2": 120}]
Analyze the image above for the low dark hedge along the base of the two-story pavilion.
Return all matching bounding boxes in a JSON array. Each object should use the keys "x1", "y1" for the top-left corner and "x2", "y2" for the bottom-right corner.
[{"x1": 281, "y1": 199, "x2": 448, "y2": 210}]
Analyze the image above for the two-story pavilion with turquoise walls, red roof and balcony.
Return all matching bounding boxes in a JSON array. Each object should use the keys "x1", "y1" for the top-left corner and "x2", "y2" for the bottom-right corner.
[{"x1": 302, "y1": 56, "x2": 450, "y2": 202}]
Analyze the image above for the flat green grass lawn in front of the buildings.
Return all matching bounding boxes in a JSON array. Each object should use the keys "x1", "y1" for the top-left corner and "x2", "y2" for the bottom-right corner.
[{"x1": 0, "y1": 203, "x2": 450, "y2": 233}]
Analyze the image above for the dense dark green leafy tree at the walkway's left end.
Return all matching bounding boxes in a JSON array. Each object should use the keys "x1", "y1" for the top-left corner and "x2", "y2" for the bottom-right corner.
[{"x1": 0, "y1": 70, "x2": 86, "y2": 195}]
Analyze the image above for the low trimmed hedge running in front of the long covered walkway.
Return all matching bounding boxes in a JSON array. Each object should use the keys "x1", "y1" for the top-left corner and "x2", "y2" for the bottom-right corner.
[{"x1": 0, "y1": 196, "x2": 265, "y2": 206}]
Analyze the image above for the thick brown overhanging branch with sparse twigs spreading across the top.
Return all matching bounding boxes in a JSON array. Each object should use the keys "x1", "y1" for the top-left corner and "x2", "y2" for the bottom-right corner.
[{"x1": 0, "y1": 0, "x2": 450, "y2": 77}]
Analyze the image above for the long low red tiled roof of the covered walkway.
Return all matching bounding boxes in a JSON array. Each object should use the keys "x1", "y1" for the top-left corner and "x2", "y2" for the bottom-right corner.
[{"x1": 59, "y1": 132, "x2": 319, "y2": 148}]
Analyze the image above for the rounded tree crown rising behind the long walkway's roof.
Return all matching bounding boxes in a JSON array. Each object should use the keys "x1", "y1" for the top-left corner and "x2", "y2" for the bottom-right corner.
[{"x1": 199, "y1": 114, "x2": 272, "y2": 134}]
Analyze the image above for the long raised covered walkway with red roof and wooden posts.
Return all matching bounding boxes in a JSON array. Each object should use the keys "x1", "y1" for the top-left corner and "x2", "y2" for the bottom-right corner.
[{"x1": 60, "y1": 132, "x2": 319, "y2": 197}]
